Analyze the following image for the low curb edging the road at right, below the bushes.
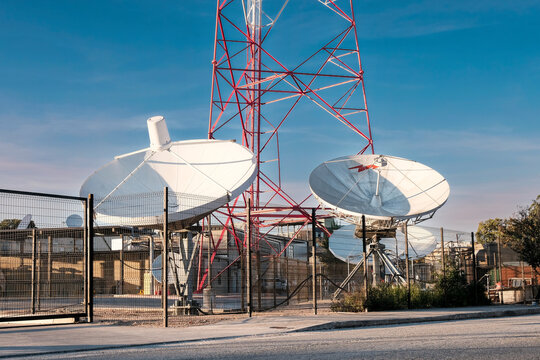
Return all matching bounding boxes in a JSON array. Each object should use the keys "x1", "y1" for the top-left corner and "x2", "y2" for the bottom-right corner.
[{"x1": 290, "y1": 307, "x2": 540, "y2": 332}]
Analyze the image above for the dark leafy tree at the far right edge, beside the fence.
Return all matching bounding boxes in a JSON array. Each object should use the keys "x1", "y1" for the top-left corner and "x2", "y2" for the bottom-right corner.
[{"x1": 503, "y1": 195, "x2": 540, "y2": 299}]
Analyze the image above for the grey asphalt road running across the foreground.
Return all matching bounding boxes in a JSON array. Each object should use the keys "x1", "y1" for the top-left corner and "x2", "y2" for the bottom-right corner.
[{"x1": 20, "y1": 315, "x2": 540, "y2": 360}]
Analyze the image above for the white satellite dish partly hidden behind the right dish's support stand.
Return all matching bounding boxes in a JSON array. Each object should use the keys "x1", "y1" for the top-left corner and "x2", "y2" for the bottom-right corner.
[{"x1": 328, "y1": 225, "x2": 467, "y2": 264}]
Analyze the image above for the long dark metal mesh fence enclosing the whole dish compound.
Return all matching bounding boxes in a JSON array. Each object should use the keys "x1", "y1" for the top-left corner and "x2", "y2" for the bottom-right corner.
[{"x1": 0, "y1": 190, "x2": 535, "y2": 321}]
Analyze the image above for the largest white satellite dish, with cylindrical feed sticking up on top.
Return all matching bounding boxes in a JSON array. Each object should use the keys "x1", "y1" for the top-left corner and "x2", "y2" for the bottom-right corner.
[{"x1": 80, "y1": 116, "x2": 256, "y2": 228}]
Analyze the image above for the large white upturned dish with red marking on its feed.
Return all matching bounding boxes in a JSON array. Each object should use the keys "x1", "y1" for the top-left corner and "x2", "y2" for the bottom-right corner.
[{"x1": 309, "y1": 155, "x2": 450, "y2": 224}]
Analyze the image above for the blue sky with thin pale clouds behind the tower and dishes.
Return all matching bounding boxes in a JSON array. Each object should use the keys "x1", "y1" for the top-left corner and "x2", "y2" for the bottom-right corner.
[{"x1": 0, "y1": 0, "x2": 540, "y2": 231}]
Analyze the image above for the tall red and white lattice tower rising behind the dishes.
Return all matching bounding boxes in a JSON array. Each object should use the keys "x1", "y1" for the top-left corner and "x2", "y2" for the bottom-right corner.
[{"x1": 198, "y1": 0, "x2": 373, "y2": 289}]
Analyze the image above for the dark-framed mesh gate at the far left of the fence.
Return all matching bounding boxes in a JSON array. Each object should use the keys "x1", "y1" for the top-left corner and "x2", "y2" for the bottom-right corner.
[{"x1": 0, "y1": 189, "x2": 92, "y2": 322}]
